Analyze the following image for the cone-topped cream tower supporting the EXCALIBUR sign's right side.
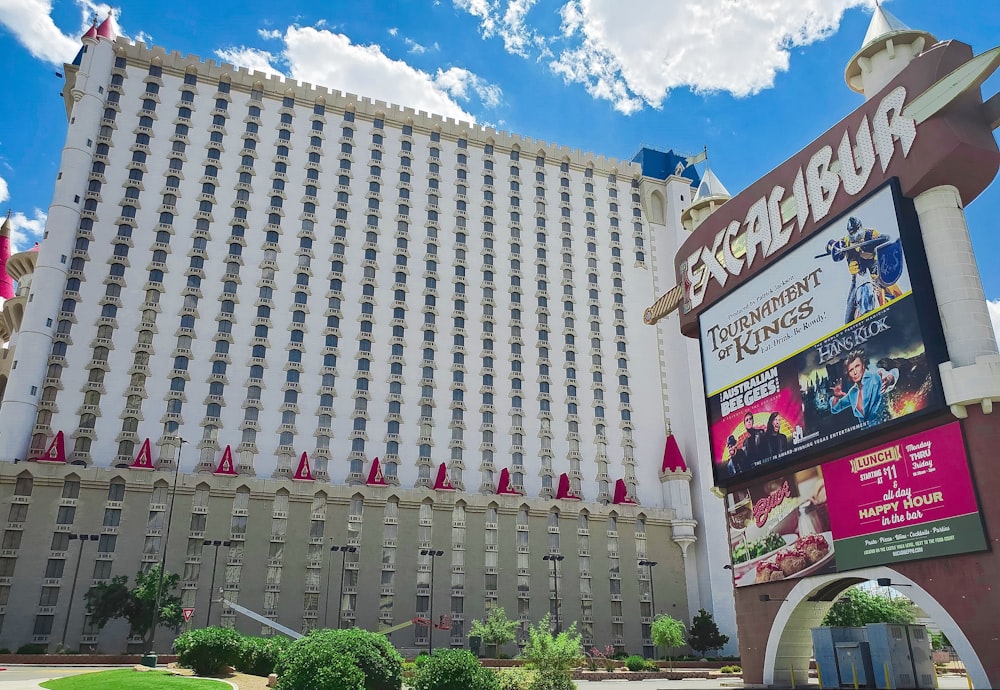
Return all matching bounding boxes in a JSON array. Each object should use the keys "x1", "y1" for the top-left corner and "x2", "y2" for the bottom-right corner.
[{"x1": 844, "y1": 6, "x2": 1000, "y2": 418}]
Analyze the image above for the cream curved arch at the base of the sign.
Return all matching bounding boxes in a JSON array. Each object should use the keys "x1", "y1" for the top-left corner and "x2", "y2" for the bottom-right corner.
[{"x1": 764, "y1": 567, "x2": 989, "y2": 688}]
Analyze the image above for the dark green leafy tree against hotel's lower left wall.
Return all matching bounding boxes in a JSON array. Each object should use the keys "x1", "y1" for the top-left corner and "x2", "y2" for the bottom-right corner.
[{"x1": 84, "y1": 565, "x2": 184, "y2": 644}]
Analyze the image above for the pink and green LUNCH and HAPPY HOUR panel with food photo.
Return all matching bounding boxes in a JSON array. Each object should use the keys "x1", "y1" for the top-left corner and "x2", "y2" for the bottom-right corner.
[{"x1": 727, "y1": 422, "x2": 986, "y2": 587}]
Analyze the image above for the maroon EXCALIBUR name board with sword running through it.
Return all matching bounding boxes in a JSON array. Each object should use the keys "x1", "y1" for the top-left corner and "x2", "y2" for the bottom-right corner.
[{"x1": 644, "y1": 41, "x2": 1000, "y2": 328}]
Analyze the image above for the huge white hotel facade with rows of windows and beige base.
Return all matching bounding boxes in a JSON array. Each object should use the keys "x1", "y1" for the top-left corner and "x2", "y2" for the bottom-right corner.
[{"x1": 0, "y1": 25, "x2": 735, "y2": 656}]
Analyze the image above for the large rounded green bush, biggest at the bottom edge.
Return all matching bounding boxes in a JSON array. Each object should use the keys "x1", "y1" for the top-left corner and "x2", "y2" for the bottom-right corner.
[{"x1": 275, "y1": 629, "x2": 404, "y2": 690}]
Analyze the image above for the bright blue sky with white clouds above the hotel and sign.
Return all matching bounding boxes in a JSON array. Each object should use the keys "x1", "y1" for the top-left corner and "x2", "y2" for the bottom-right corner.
[{"x1": 0, "y1": 0, "x2": 1000, "y2": 321}]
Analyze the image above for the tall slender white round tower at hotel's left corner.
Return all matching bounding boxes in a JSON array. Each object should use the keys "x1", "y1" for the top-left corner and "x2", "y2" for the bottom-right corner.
[{"x1": 0, "y1": 16, "x2": 114, "y2": 461}]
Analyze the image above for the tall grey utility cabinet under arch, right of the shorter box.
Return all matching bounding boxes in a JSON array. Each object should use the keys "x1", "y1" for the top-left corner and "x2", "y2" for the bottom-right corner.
[{"x1": 866, "y1": 623, "x2": 935, "y2": 690}]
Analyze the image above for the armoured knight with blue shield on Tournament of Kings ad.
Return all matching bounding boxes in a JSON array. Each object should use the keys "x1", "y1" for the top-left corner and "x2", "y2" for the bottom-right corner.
[{"x1": 816, "y1": 216, "x2": 903, "y2": 323}]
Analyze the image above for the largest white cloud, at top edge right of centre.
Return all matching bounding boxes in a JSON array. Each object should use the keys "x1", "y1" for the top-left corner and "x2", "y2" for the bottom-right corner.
[{"x1": 453, "y1": 0, "x2": 871, "y2": 113}]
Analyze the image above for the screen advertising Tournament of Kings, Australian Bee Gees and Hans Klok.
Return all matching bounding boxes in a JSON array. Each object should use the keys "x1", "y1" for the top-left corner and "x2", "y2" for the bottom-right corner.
[{"x1": 700, "y1": 185, "x2": 943, "y2": 485}]
